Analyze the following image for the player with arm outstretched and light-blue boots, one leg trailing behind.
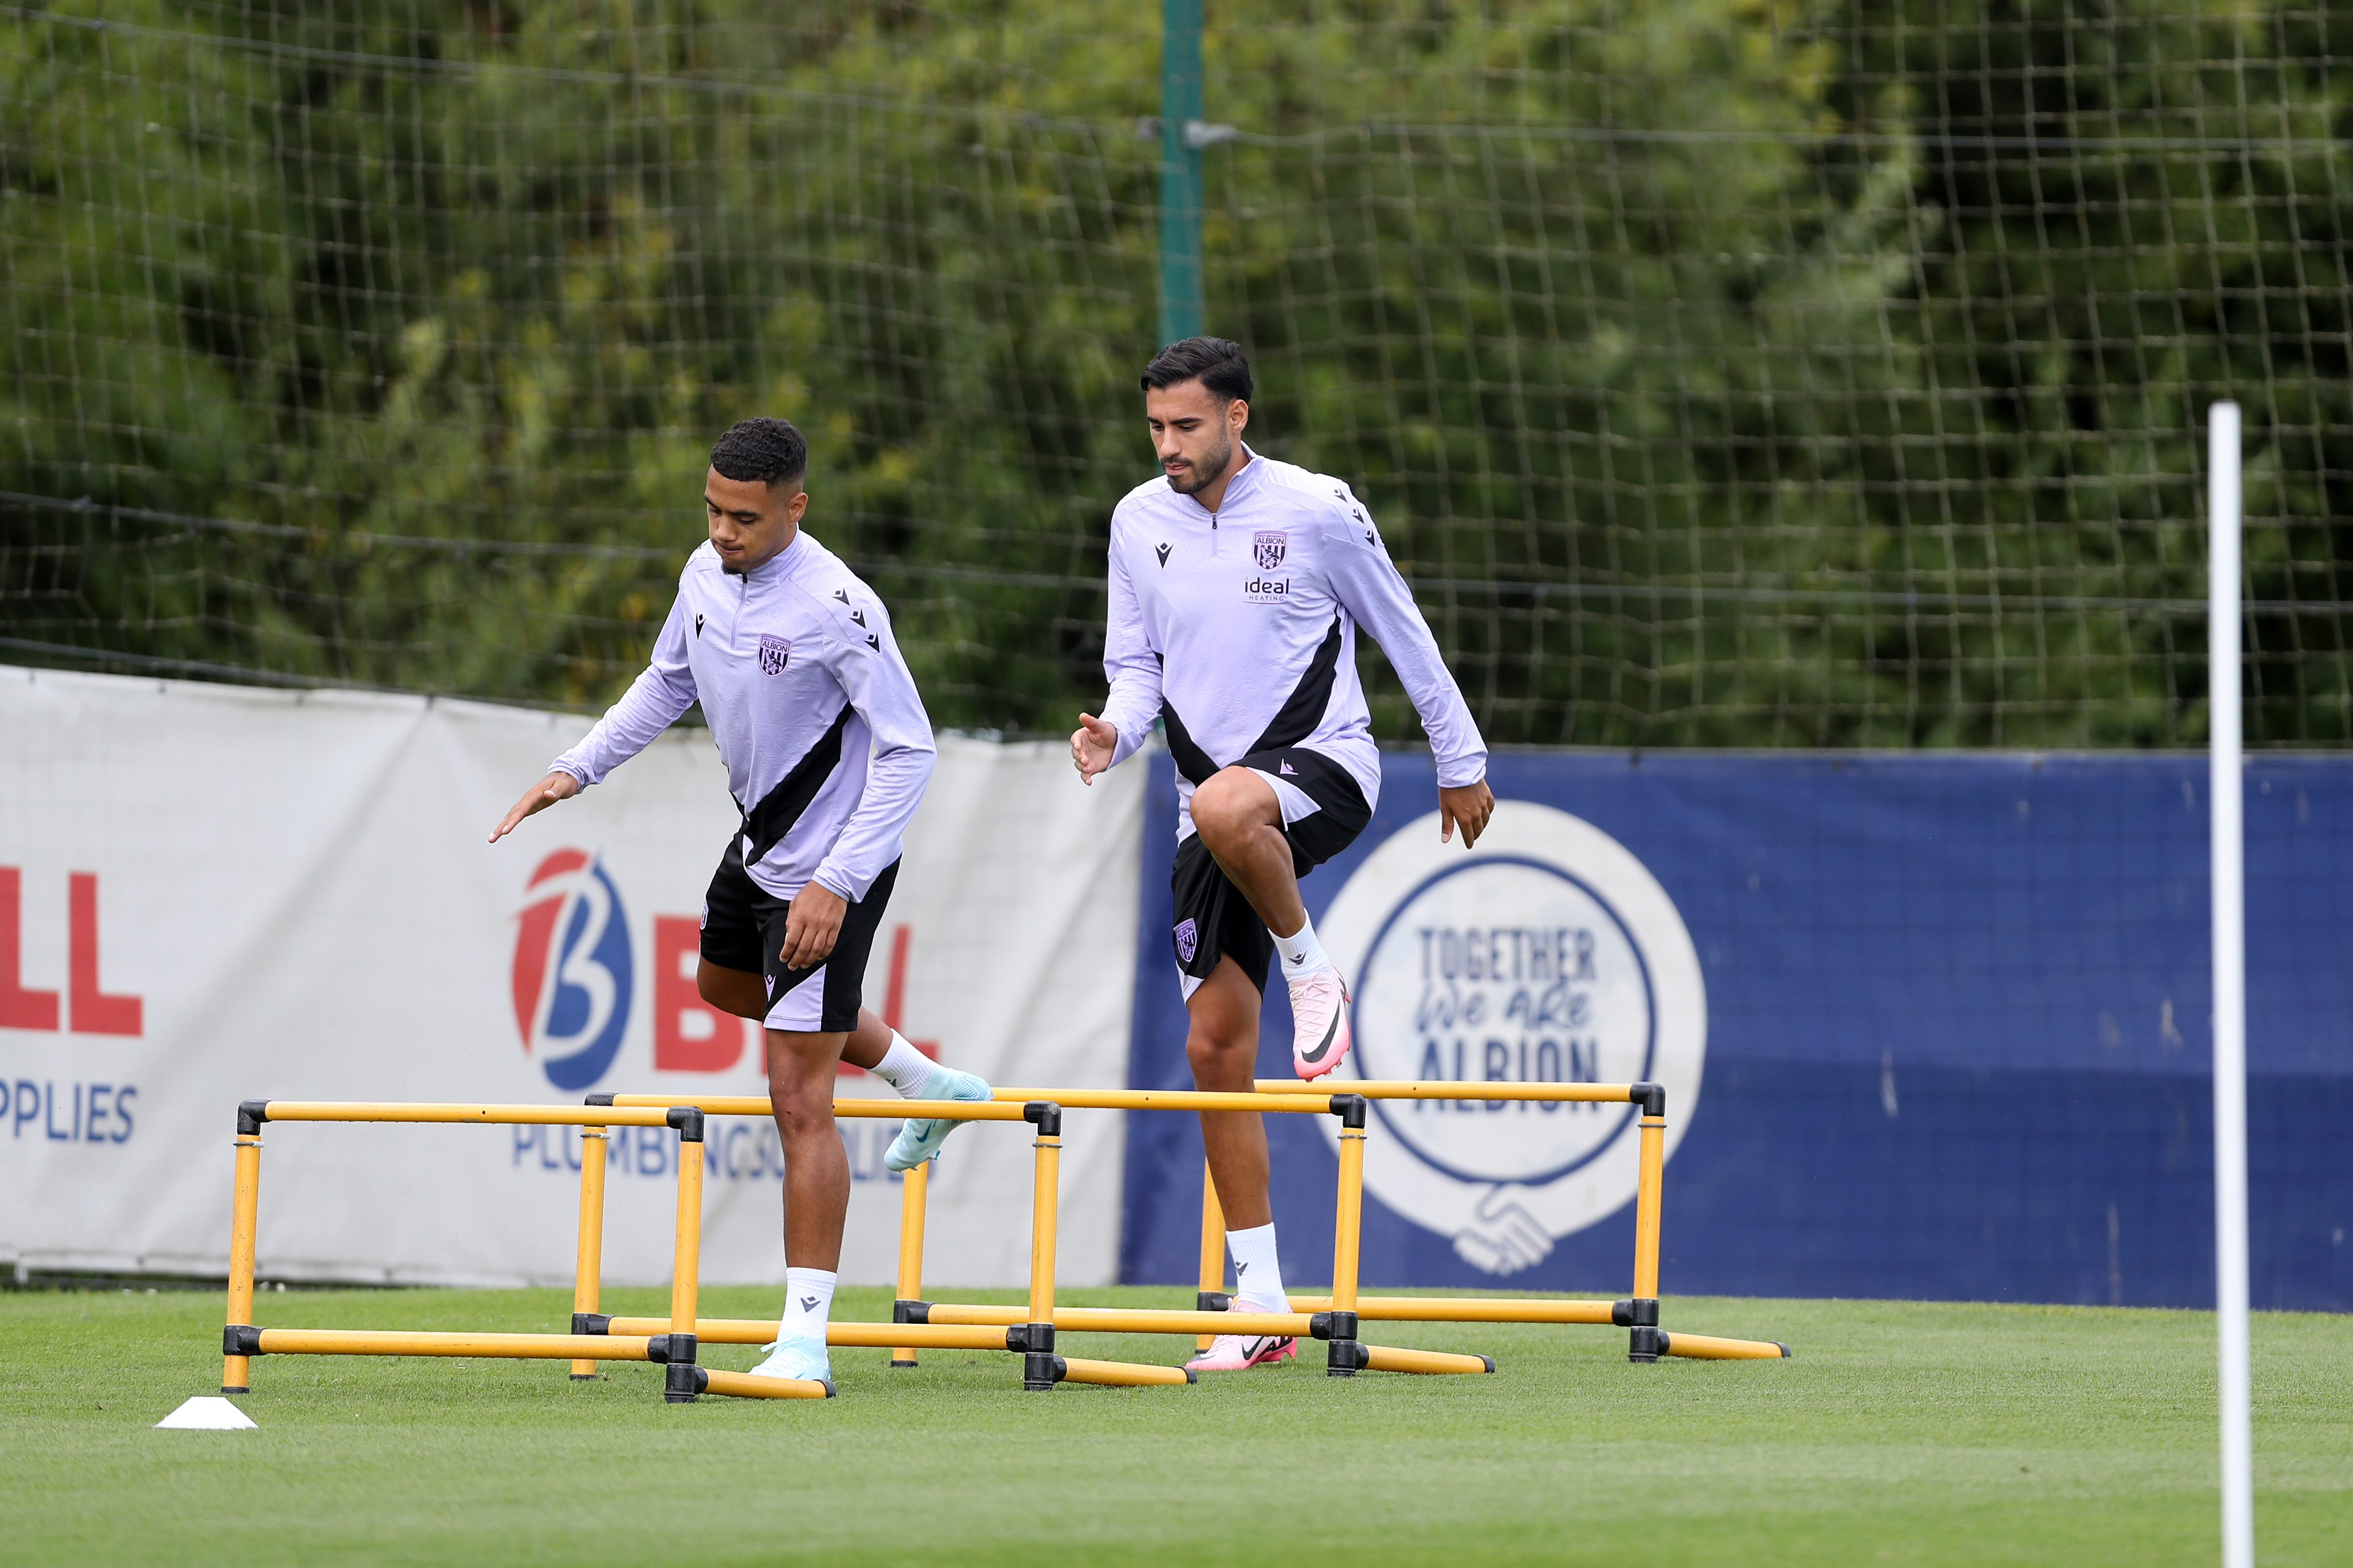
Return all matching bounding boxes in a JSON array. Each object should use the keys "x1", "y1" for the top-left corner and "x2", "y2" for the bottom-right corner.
[{"x1": 489, "y1": 418, "x2": 988, "y2": 1382}]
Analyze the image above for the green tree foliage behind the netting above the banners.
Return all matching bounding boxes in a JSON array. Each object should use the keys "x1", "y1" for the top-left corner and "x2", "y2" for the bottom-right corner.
[{"x1": 0, "y1": 0, "x2": 2353, "y2": 745}]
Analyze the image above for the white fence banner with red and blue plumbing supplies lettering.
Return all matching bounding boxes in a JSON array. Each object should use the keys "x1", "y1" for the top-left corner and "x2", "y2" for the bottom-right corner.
[{"x1": 0, "y1": 668, "x2": 1143, "y2": 1286}]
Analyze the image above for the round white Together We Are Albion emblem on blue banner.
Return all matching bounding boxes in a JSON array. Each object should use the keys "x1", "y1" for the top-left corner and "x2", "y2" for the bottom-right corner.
[{"x1": 1318, "y1": 802, "x2": 1706, "y2": 1274}]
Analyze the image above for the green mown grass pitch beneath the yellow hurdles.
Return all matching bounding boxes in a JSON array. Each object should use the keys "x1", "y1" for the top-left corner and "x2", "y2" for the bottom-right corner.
[{"x1": 0, "y1": 1288, "x2": 2353, "y2": 1568}]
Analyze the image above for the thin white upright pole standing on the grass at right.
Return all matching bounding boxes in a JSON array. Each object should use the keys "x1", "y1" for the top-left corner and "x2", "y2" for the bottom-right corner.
[{"x1": 2207, "y1": 402, "x2": 2254, "y2": 1568}]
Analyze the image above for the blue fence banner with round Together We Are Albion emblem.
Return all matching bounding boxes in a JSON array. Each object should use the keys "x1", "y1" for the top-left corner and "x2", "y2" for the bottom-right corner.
[{"x1": 1122, "y1": 752, "x2": 2353, "y2": 1312}]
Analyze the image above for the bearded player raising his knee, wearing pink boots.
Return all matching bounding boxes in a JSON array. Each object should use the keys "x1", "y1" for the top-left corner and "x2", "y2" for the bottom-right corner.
[{"x1": 1071, "y1": 339, "x2": 1494, "y2": 1371}]
